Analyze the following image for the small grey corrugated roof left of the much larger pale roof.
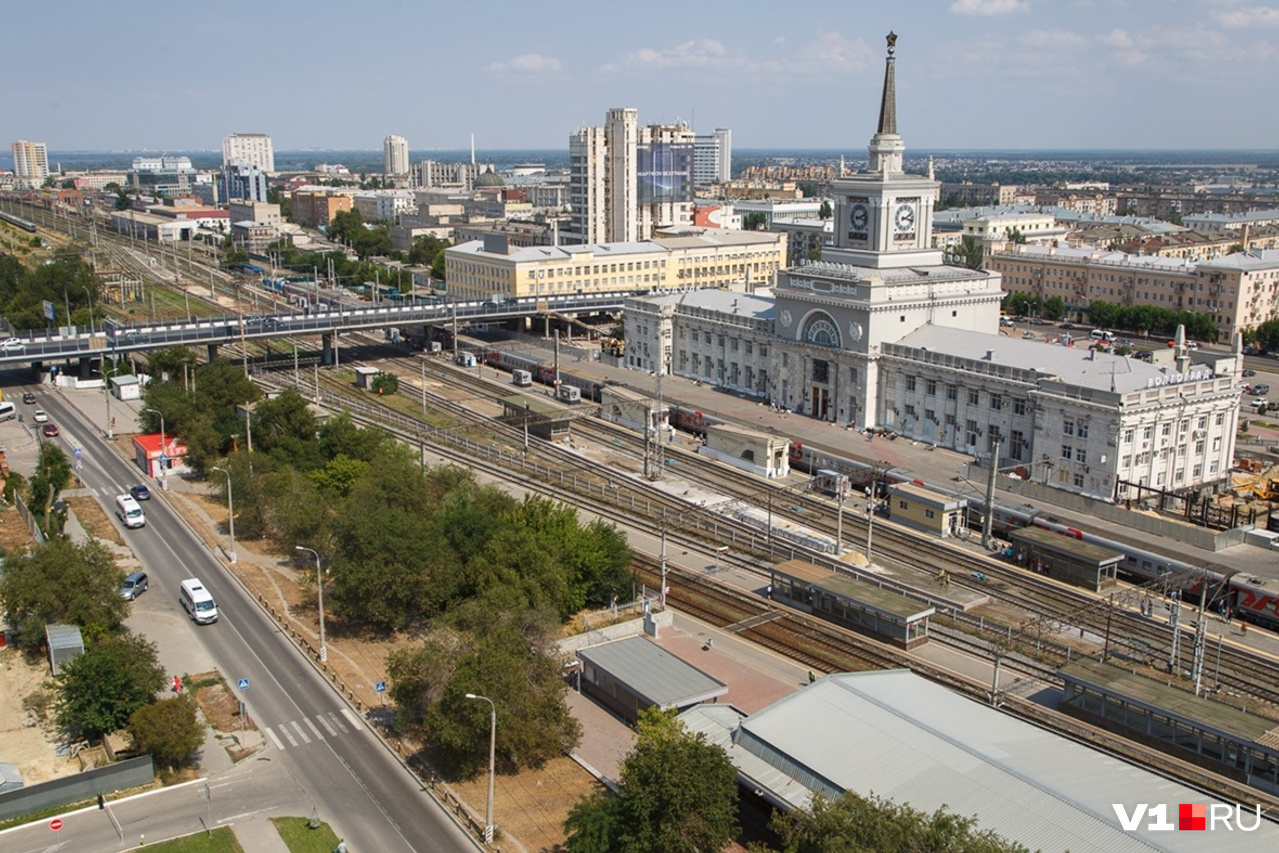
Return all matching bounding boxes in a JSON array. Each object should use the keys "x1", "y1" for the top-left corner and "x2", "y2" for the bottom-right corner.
[{"x1": 577, "y1": 637, "x2": 728, "y2": 708}]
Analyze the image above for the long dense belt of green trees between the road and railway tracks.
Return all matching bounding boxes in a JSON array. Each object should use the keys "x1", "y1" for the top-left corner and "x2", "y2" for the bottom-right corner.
[{"x1": 143, "y1": 365, "x2": 633, "y2": 772}]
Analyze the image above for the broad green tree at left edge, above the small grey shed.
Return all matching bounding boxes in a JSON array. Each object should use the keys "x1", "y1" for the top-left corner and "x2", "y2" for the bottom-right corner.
[{"x1": 0, "y1": 538, "x2": 129, "y2": 647}]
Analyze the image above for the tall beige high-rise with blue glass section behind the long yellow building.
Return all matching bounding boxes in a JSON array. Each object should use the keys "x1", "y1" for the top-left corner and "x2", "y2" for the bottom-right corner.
[{"x1": 568, "y1": 107, "x2": 693, "y2": 243}]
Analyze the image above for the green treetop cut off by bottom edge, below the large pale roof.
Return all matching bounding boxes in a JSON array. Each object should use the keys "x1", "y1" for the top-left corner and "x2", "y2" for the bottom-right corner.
[{"x1": 771, "y1": 792, "x2": 1028, "y2": 853}]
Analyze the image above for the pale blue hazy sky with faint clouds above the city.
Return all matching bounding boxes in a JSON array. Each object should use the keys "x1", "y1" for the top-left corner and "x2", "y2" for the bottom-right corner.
[{"x1": 7, "y1": 0, "x2": 1279, "y2": 153}]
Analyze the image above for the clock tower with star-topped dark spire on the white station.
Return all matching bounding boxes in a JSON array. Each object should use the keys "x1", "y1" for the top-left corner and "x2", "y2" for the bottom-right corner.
[{"x1": 822, "y1": 33, "x2": 941, "y2": 269}]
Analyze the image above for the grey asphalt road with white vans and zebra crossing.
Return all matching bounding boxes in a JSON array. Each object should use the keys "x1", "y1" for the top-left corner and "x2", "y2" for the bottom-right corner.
[{"x1": 16, "y1": 390, "x2": 478, "y2": 853}]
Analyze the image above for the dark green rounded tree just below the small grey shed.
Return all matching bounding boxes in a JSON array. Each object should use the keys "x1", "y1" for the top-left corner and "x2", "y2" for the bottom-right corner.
[{"x1": 54, "y1": 632, "x2": 165, "y2": 740}]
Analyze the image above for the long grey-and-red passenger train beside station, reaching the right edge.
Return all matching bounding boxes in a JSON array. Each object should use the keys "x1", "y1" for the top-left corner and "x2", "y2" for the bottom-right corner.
[{"x1": 790, "y1": 441, "x2": 1279, "y2": 629}]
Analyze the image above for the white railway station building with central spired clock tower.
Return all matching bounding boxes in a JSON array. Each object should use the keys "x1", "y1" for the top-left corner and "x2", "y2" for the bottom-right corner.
[{"x1": 624, "y1": 40, "x2": 1243, "y2": 501}]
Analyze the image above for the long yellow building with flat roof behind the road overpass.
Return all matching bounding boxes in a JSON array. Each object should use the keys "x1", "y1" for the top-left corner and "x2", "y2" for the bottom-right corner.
[{"x1": 444, "y1": 231, "x2": 787, "y2": 302}]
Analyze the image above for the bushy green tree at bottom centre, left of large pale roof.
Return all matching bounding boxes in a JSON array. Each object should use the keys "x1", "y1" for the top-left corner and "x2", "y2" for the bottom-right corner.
[{"x1": 564, "y1": 708, "x2": 736, "y2": 853}]
